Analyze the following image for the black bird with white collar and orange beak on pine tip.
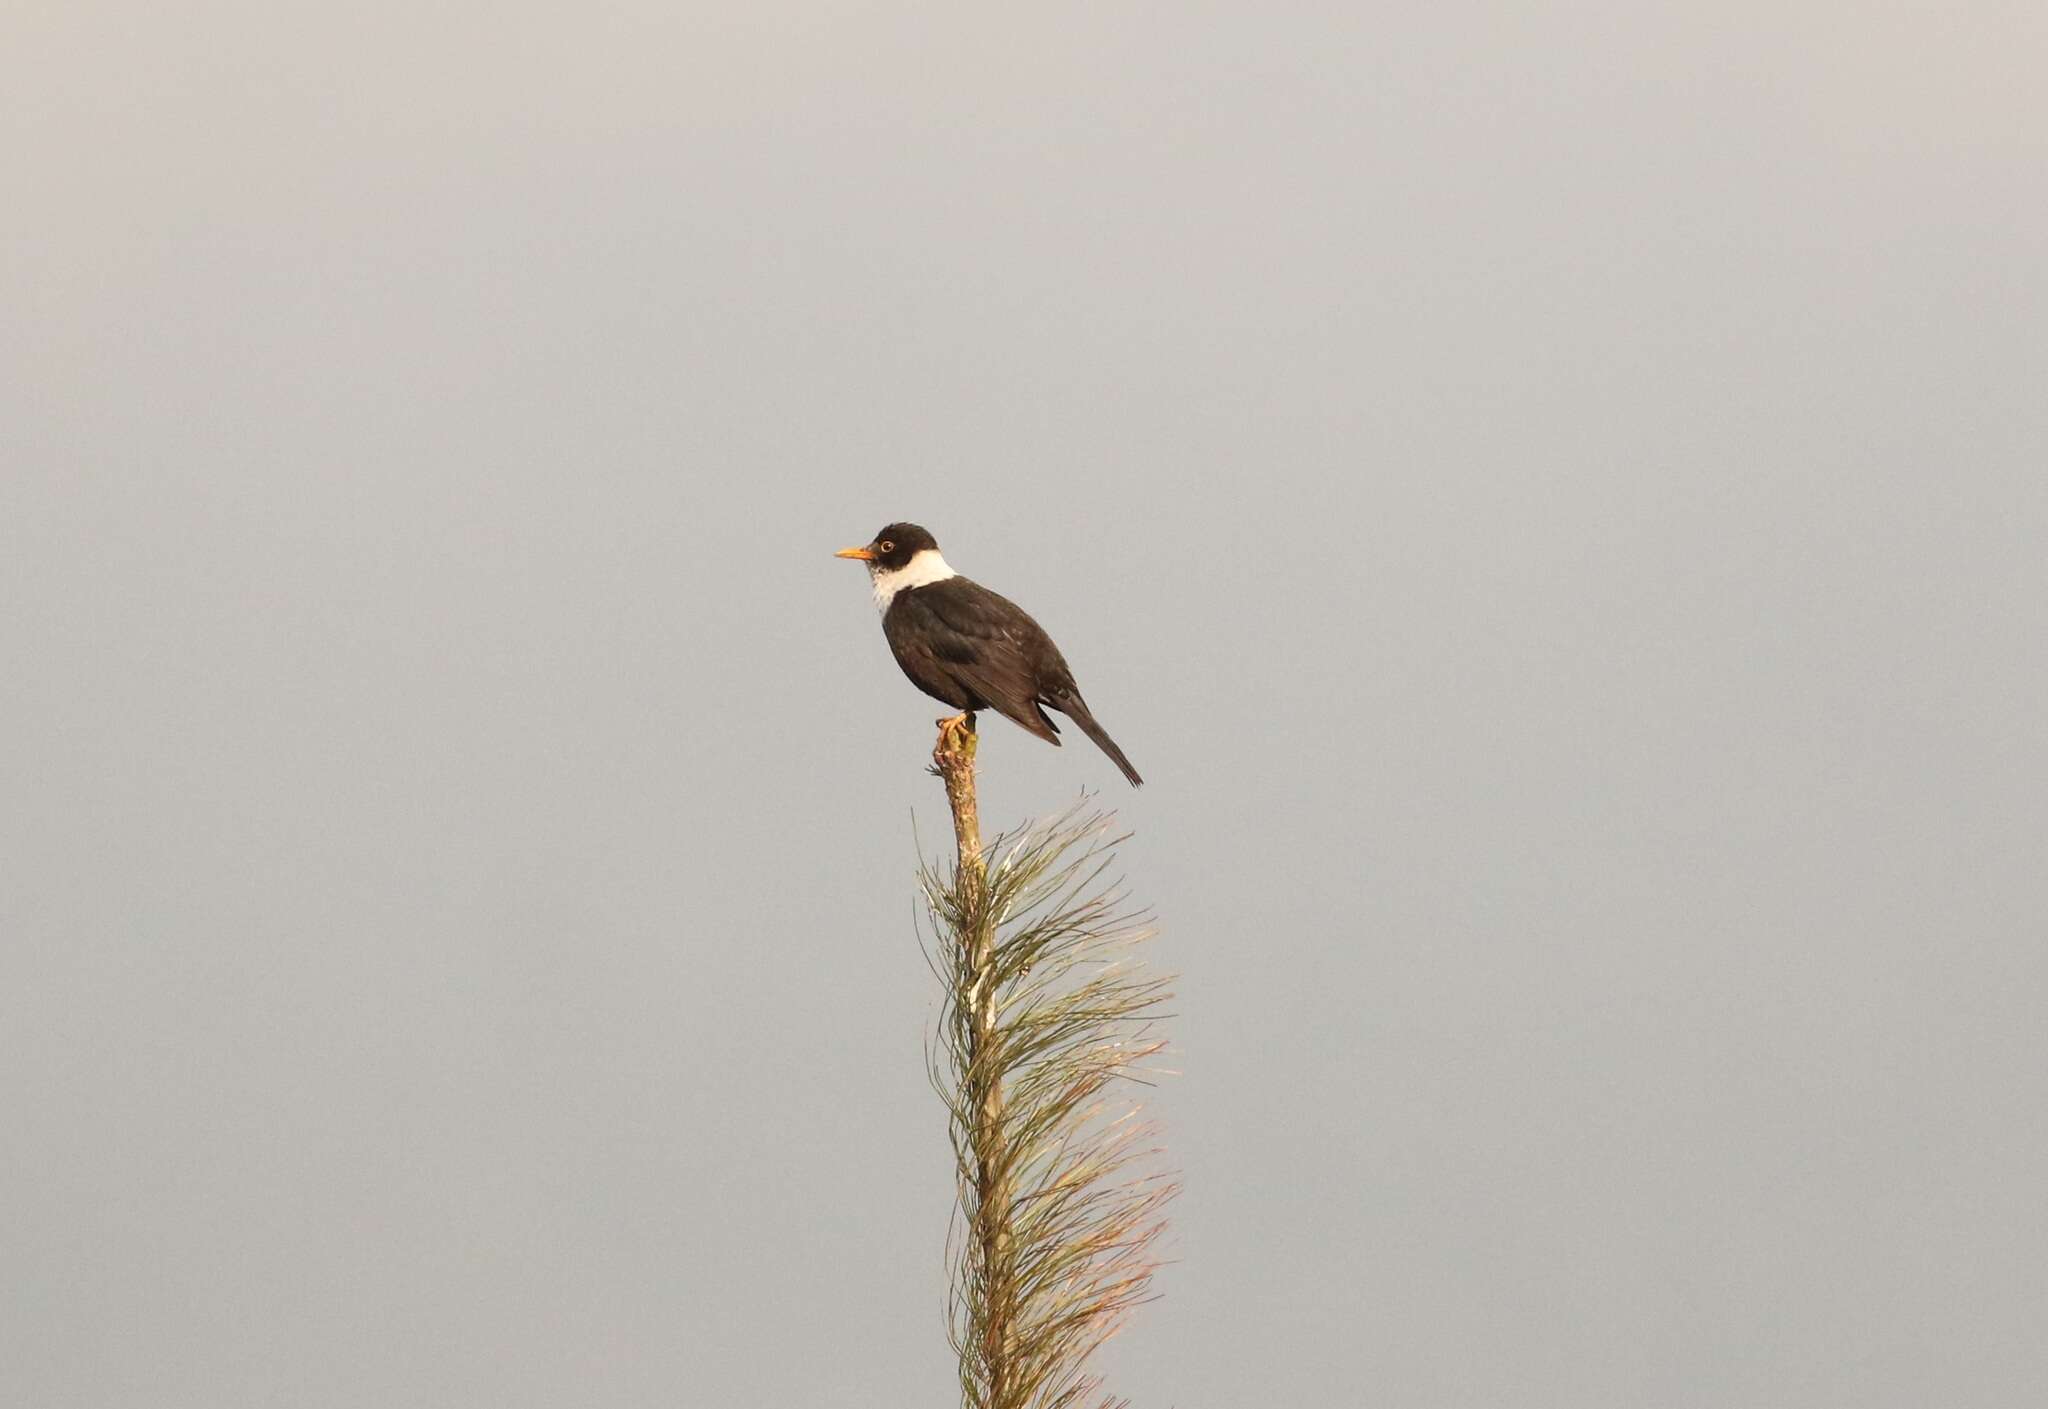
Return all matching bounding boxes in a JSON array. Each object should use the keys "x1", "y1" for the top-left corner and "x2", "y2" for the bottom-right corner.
[{"x1": 836, "y1": 524, "x2": 1145, "y2": 786}]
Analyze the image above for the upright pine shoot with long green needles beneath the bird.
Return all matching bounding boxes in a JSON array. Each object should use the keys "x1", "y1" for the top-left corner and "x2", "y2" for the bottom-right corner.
[{"x1": 920, "y1": 794, "x2": 1180, "y2": 1409}]
